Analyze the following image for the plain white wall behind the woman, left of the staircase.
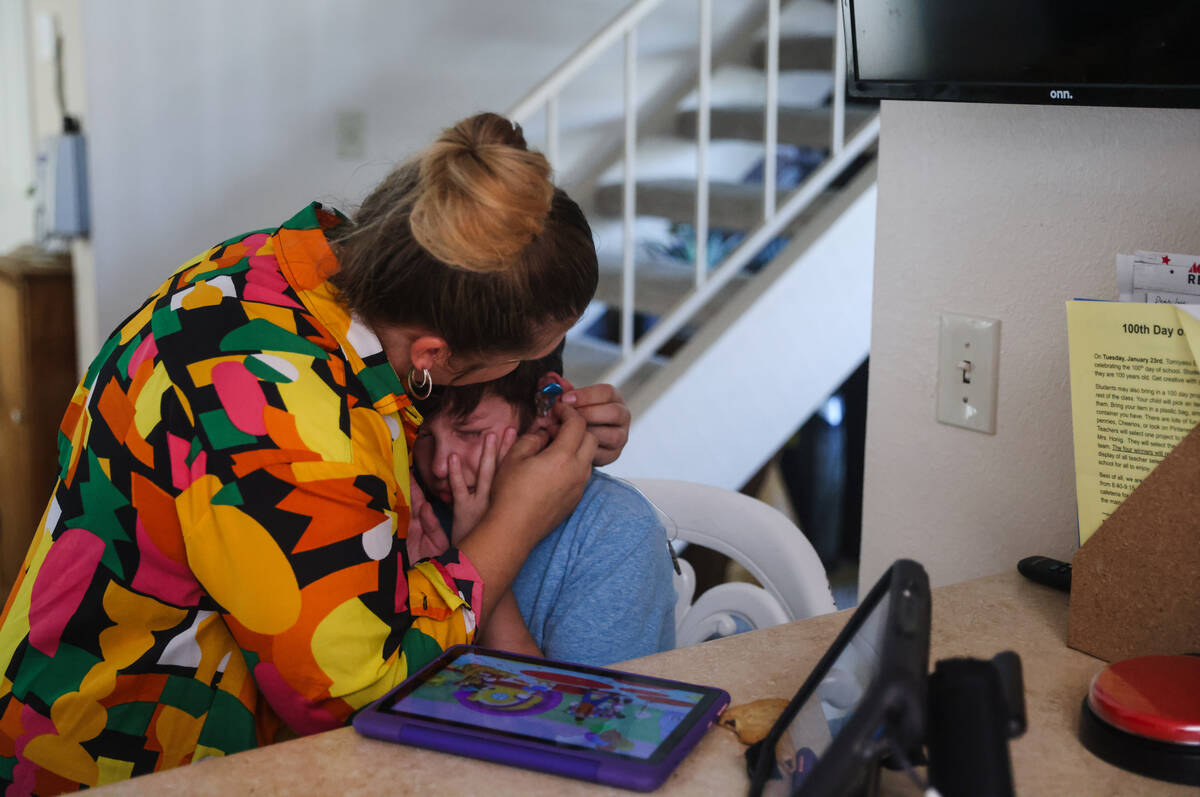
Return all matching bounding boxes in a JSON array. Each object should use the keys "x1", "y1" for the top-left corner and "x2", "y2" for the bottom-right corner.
[{"x1": 75, "y1": 0, "x2": 748, "y2": 358}]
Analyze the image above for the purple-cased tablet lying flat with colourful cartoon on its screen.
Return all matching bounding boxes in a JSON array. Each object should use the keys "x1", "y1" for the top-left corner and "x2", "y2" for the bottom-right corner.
[{"x1": 354, "y1": 645, "x2": 730, "y2": 791}]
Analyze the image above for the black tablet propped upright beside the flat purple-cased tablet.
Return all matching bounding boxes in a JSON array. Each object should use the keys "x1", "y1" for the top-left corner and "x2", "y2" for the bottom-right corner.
[{"x1": 746, "y1": 559, "x2": 930, "y2": 797}]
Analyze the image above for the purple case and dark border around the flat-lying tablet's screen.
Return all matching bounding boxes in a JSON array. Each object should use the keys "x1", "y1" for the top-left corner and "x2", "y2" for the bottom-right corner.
[{"x1": 354, "y1": 646, "x2": 730, "y2": 791}]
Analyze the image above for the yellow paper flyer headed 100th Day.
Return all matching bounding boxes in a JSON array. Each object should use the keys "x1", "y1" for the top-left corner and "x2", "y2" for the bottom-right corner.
[{"x1": 1067, "y1": 301, "x2": 1200, "y2": 545}]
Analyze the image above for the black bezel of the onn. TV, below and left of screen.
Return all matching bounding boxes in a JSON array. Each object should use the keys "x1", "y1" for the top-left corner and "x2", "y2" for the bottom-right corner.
[{"x1": 841, "y1": 0, "x2": 1200, "y2": 108}]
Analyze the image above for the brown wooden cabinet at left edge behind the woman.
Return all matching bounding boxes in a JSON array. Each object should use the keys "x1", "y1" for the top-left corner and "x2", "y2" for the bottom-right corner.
[{"x1": 0, "y1": 250, "x2": 78, "y2": 595}]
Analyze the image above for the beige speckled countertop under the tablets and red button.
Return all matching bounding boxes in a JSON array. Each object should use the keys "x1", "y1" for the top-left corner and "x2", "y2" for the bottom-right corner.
[{"x1": 87, "y1": 571, "x2": 1196, "y2": 797}]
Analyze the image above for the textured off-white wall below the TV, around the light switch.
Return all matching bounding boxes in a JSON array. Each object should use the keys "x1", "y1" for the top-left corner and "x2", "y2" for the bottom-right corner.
[{"x1": 860, "y1": 102, "x2": 1200, "y2": 586}]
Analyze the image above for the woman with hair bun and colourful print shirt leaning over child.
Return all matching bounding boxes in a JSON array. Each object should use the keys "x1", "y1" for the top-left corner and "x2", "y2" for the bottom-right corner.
[{"x1": 0, "y1": 114, "x2": 628, "y2": 795}]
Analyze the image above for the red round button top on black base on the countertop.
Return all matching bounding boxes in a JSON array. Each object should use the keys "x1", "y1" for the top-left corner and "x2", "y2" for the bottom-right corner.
[{"x1": 1087, "y1": 655, "x2": 1200, "y2": 744}]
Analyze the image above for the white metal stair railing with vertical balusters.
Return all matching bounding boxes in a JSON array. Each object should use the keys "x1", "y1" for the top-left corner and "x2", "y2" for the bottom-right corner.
[{"x1": 508, "y1": 0, "x2": 880, "y2": 386}]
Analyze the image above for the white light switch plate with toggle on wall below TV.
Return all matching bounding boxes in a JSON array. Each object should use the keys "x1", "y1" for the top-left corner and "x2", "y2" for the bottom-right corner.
[{"x1": 937, "y1": 313, "x2": 1000, "y2": 435}]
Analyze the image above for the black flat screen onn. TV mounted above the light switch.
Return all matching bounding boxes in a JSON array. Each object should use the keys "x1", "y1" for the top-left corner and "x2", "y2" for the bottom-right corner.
[{"x1": 841, "y1": 0, "x2": 1200, "y2": 108}]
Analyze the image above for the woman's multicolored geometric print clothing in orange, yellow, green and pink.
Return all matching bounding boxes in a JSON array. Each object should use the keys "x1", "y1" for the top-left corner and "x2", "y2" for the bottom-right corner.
[{"x1": 0, "y1": 204, "x2": 482, "y2": 796}]
